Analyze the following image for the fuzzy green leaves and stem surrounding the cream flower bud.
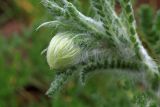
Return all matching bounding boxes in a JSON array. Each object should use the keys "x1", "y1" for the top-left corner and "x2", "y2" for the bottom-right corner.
[{"x1": 38, "y1": 0, "x2": 160, "y2": 105}]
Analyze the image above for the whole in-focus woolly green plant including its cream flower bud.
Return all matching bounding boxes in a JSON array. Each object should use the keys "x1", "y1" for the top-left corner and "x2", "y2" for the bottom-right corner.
[{"x1": 38, "y1": 0, "x2": 159, "y2": 95}]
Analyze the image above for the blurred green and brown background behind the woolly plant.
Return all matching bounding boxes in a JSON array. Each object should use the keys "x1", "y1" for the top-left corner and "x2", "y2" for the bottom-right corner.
[{"x1": 0, "y1": 0, "x2": 160, "y2": 107}]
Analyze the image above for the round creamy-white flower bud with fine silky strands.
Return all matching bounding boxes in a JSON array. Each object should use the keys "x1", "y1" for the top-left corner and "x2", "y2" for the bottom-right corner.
[{"x1": 47, "y1": 32, "x2": 80, "y2": 70}]
